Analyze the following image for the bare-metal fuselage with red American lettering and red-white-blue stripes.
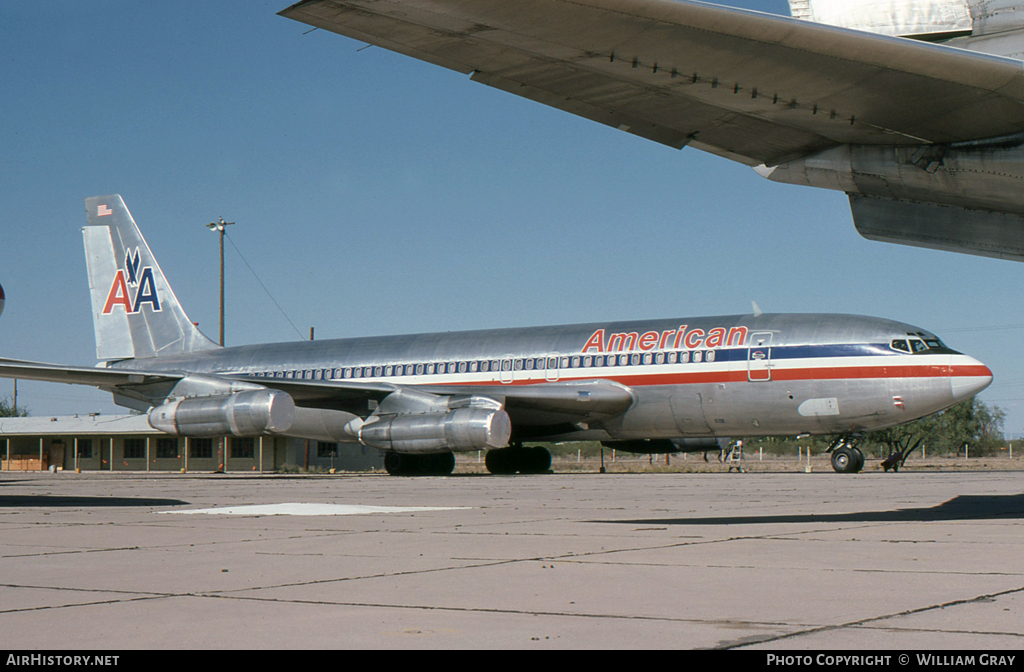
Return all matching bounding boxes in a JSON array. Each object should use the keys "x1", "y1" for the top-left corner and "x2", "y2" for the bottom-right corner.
[{"x1": 109, "y1": 314, "x2": 991, "y2": 440}]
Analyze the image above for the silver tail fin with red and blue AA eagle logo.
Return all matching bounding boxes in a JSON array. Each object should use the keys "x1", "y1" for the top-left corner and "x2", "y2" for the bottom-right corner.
[{"x1": 82, "y1": 195, "x2": 218, "y2": 360}]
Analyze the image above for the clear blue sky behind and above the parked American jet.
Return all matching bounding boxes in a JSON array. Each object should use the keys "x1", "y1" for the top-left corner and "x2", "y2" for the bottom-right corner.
[{"x1": 6, "y1": 0, "x2": 1024, "y2": 433}]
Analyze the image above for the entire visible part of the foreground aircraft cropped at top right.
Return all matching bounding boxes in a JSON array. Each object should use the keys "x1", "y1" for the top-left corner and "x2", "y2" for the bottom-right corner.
[{"x1": 281, "y1": 0, "x2": 1024, "y2": 261}]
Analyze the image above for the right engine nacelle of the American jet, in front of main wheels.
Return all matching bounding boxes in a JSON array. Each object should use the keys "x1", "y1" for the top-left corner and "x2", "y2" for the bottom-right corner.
[{"x1": 359, "y1": 408, "x2": 512, "y2": 454}]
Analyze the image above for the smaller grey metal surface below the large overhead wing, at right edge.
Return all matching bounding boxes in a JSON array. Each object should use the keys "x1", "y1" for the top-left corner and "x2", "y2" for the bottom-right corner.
[{"x1": 850, "y1": 195, "x2": 1024, "y2": 261}]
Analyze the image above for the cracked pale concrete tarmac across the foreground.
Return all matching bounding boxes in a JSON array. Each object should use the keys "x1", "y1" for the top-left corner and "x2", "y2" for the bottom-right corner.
[{"x1": 0, "y1": 472, "x2": 1024, "y2": 650}]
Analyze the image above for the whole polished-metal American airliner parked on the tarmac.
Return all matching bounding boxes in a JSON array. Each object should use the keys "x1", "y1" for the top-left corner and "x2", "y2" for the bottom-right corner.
[{"x1": 0, "y1": 195, "x2": 992, "y2": 474}]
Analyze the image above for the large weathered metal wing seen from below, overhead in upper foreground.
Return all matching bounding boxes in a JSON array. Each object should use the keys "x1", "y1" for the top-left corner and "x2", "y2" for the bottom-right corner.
[{"x1": 281, "y1": 0, "x2": 1024, "y2": 166}]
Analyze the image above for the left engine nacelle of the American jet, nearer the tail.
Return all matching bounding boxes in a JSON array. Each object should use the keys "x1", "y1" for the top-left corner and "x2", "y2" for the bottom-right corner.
[{"x1": 150, "y1": 389, "x2": 295, "y2": 436}]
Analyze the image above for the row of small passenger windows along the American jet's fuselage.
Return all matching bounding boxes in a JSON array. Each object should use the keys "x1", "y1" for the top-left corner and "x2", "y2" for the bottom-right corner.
[{"x1": 255, "y1": 350, "x2": 715, "y2": 380}]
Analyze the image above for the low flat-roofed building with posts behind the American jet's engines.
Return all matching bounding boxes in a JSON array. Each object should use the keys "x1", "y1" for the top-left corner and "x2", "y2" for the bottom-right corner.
[{"x1": 0, "y1": 414, "x2": 384, "y2": 472}]
